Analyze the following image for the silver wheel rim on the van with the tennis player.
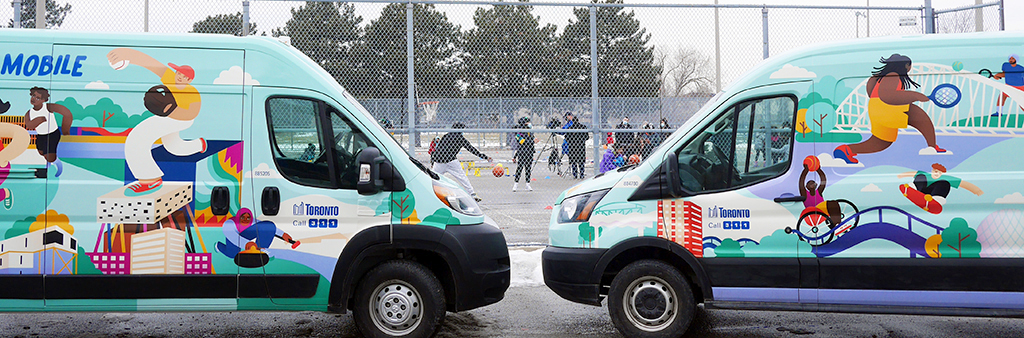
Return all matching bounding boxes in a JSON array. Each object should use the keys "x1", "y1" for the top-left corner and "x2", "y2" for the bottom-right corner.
[{"x1": 623, "y1": 276, "x2": 679, "y2": 332}]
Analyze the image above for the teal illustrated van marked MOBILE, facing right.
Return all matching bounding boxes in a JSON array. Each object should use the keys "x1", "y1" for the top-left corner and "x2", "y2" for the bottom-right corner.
[{"x1": 0, "y1": 30, "x2": 510, "y2": 337}]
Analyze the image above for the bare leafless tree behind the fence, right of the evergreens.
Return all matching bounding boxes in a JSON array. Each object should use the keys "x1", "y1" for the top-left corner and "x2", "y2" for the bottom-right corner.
[{"x1": 654, "y1": 47, "x2": 715, "y2": 96}]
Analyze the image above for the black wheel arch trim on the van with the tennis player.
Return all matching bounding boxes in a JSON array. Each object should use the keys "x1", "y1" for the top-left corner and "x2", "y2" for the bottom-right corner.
[{"x1": 593, "y1": 237, "x2": 714, "y2": 303}]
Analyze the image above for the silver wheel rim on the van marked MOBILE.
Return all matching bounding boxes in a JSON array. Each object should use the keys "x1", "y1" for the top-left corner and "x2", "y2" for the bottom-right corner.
[{"x1": 370, "y1": 280, "x2": 423, "y2": 336}]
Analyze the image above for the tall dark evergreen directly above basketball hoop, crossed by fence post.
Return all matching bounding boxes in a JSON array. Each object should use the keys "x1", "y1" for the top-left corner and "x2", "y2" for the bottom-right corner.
[{"x1": 353, "y1": 3, "x2": 462, "y2": 97}]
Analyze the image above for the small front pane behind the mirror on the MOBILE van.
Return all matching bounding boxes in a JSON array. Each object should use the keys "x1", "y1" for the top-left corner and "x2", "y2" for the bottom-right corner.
[{"x1": 328, "y1": 108, "x2": 373, "y2": 189}]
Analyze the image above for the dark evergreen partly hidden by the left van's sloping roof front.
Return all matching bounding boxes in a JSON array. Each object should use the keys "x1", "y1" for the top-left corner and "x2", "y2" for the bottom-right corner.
[{"x1": 270, "y1": 1, "x2": 374, "y2": 97}]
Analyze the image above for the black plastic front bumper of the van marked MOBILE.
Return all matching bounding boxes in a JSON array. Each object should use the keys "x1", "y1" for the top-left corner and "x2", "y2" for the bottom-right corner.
[{"x1": 441, "y1": 222, "x2": 512, "y2": 311}]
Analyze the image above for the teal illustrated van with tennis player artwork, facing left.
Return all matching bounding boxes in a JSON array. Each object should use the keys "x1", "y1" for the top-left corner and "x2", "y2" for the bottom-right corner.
[{"x1": 543, "y1": 32, "x2": 1024, "y2": 337}]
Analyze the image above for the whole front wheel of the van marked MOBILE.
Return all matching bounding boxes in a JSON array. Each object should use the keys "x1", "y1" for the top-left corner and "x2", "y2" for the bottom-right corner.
[{"x1": 352, "y1": 260, "x2": 445, "y2": 338}]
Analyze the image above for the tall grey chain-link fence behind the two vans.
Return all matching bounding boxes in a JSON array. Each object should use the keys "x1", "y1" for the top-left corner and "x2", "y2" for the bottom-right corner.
[{"x1": 0, "y1": 0, "x2": 1004, "y2": 242}]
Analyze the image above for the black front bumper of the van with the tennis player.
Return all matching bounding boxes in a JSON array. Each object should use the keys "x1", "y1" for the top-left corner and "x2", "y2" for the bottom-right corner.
[{"x1": 541, "y1": 247, "x2": 608, "y2": 306}]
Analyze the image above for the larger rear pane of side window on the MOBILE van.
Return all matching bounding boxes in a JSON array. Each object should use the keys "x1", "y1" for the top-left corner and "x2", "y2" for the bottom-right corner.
[{"x1": 266, "y1": 97, "x2": 333, "y2": 187}]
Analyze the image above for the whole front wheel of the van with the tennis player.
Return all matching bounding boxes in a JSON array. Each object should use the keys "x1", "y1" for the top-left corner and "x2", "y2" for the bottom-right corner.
[{"x1": 608, "y1": 259, "x2": 696, "y2": 338}]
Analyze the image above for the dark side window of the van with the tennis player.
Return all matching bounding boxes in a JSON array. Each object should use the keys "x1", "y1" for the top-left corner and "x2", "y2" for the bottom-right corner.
[{"x1": 678, "y1": 96, "x2": 796, "y2": 194}]
